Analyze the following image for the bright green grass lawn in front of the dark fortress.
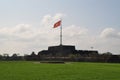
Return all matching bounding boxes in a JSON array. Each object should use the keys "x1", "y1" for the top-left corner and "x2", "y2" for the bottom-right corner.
[{"x1": 0, "y1": 61, "x2": 120, "y2": 80}]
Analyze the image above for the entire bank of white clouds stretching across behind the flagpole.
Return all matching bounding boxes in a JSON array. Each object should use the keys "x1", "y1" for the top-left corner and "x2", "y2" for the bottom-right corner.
[{"x1": 0, "y1": 13, "x2": 120, "y2": 55}]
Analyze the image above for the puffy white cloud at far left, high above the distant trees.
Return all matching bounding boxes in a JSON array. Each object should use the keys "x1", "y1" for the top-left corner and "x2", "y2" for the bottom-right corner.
[{"x1": 0, "y1": 24, "x2": 35, "y2": 39}]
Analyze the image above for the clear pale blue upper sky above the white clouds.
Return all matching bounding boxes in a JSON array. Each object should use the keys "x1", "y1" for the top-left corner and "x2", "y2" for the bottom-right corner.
[{"x1": 0, "y1": 0, "x2": 120, "y2": 28}]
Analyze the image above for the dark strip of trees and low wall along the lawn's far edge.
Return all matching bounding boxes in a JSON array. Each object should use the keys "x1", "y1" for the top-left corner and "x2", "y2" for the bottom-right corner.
[{"x1": 0, "y1": 52, "x2": 120, "y2": 63}]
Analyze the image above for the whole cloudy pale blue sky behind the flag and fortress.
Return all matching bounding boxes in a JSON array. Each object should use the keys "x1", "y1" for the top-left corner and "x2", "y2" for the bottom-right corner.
[{"x1": 0, "y1": 0, "x2": 120, "y2": 55}]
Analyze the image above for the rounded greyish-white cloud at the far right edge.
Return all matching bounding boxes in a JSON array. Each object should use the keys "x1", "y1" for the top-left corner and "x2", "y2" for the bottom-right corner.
[{"x1": 90, "y1": 28, "x2": 120, "y2": 54}]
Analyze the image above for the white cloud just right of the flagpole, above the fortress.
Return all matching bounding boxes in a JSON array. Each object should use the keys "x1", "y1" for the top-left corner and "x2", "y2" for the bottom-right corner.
[{"x1": 63, "y1": 25, "x2": 88, "y2": 45}]
